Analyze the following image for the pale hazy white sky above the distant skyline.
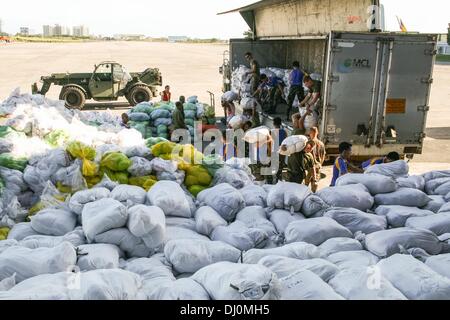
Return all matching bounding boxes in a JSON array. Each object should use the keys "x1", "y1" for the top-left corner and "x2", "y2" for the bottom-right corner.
[{"x1": 0, "y1": 0, "x2": 450, "y2": 39}]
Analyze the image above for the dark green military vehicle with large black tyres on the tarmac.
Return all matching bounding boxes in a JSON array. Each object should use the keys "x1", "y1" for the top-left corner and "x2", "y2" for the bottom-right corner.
[{"x1": 32, "y1": 61, "x2": 162, "y2": 109}]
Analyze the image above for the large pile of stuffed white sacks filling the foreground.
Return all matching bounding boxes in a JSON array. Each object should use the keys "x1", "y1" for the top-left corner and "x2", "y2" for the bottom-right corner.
[{"x1": 0, "y1": 154, "x2": 450, "y2": 300}]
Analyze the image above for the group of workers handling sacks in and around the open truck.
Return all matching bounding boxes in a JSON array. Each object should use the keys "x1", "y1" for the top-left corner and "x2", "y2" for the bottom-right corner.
[{"x1": 222, "y1": 52, "x2": 400, "y2": 192}]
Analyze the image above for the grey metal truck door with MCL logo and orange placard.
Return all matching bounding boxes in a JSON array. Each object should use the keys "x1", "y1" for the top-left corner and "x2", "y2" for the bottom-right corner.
[{"x1": 321, "y1": 33, "x2": 435, "y2": 156}]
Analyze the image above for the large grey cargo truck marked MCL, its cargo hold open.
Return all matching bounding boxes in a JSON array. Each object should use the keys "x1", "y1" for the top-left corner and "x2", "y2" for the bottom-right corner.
[{"x1": 221, "y1": 0, "x2": 437, "y2": 159}]
